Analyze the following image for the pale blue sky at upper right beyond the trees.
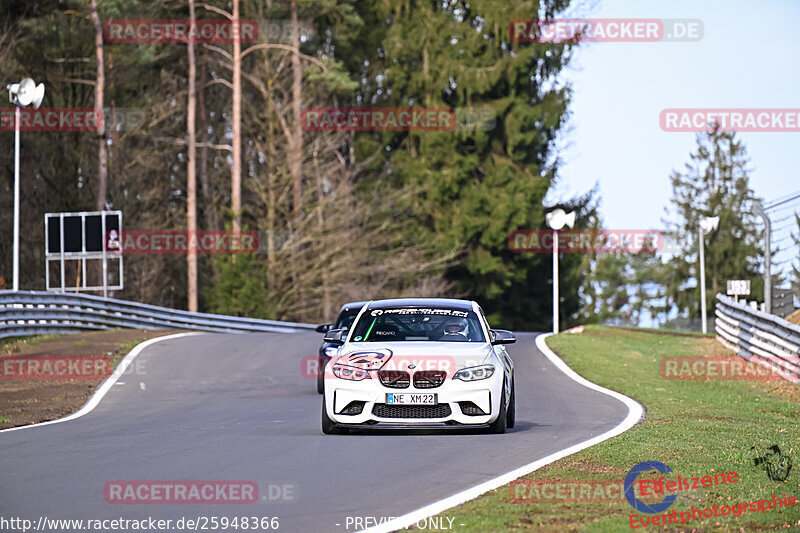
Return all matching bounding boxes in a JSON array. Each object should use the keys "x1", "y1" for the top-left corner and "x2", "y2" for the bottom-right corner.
[{"x1": 547, "y1": 0, "x2": 800, "y2": 280}]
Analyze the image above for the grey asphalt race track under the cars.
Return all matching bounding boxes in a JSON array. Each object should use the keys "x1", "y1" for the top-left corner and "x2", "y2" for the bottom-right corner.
[{"x1": 0, "y1": 332, "x2": 628, "y2": 532}]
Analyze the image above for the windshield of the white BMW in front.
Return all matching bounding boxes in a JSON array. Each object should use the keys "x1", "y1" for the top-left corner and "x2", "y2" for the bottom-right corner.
[{"x1": 350, "y1": 307, "x2": 485, "y2": 342}]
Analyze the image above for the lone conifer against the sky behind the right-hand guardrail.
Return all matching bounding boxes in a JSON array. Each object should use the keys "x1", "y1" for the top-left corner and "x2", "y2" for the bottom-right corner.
[{"x1": 656, "y1": 129, "x2": 764, "y2": 319}]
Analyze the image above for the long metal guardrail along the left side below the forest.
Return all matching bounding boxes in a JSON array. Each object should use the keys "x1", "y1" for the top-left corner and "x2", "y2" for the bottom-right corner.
[{"x1": 0, "y1": 291, "x2": 315, "y2": 339}]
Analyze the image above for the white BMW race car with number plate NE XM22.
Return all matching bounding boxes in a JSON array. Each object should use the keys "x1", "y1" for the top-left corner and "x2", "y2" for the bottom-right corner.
[{"x1": 322, "y1": 298, "x2": 516, "y2": 434}]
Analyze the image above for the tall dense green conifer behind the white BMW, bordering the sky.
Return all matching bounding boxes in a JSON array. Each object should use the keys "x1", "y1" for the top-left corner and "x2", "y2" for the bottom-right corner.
[{"x1": 361, "y1": 0, "x2": 586, "y2": 328}]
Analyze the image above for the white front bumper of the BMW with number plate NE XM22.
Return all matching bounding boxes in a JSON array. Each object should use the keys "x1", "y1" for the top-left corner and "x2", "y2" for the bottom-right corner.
[{"x1": 325, "y1": 372, "x2": 503, "y2": 429}]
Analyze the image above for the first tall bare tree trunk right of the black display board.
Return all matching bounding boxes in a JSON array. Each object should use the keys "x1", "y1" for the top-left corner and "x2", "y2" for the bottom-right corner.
[{"x1": 186, "y1": 0, "x2": 197, "y2": 313}]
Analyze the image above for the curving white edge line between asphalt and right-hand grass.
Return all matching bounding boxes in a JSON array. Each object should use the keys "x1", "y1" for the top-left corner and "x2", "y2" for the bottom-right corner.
[{"x1": 361, "y1": 333, "x2": 644, "y2": 533}]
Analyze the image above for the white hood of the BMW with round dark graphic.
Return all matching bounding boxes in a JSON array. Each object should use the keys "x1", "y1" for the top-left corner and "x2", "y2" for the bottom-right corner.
[{"x1": 337, "y1": 341, "x2": 492, "y2": 374}]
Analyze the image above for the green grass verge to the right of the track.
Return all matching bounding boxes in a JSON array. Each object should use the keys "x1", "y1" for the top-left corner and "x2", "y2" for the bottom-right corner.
[{"x1": 418, "y1": 326, "x2": 800, "y2": 533}]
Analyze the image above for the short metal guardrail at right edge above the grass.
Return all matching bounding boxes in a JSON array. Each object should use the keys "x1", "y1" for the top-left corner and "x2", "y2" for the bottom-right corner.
[{"x1": 715, "y1": 294, "x2": 800, "y2": 383}]
